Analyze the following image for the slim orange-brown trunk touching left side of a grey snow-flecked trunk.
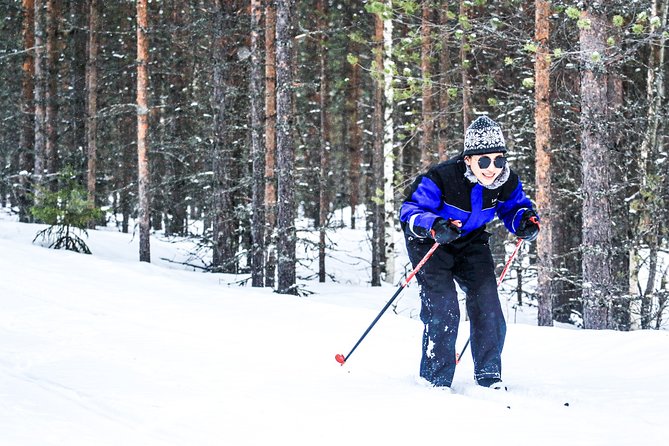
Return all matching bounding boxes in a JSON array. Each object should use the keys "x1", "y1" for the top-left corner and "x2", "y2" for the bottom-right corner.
[{"x1": 265, "y1": 0, "x2": 276, "y2": 288}]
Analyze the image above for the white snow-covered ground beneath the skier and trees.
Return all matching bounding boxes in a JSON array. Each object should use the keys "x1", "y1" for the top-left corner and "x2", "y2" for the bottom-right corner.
[{"x1": 0, "y1": 210, "x2": 669, "y2": 446}]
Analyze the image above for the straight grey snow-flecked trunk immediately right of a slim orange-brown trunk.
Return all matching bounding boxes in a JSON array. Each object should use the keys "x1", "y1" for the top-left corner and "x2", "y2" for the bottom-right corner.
[{"x1": 276, "y1": 0, "x2": 297, "y2": 294}]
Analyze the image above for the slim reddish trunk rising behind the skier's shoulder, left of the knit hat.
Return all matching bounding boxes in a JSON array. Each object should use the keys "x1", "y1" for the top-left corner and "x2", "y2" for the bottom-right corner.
[{"x1": 419, "y1": 0, "x2": 434, "y2": 170}]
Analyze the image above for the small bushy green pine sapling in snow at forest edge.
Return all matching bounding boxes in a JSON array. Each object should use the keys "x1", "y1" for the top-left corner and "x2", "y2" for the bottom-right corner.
[{"x1": 30, "y1": 167, "x2": 102, "y2": 254}]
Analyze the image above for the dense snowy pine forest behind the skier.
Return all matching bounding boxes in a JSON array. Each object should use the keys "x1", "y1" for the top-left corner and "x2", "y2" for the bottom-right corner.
[{"x1": 0, "y1": 0, "x2": 669, "y2": 330}]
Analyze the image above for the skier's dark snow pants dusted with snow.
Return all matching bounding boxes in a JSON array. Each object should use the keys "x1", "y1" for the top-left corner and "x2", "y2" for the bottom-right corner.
[{"x1": 407, "y1": 232, "x2": 506, "y2": 387}]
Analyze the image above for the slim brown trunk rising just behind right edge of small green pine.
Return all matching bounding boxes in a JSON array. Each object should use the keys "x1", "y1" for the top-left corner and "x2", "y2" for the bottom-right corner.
[{"x1": 86, "y1": 0, "x2": 99, "y2": 228}]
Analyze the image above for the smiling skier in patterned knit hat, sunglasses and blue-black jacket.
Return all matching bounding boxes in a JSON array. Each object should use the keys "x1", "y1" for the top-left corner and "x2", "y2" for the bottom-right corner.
[{"x1": 400, "y1": 116, "x2": 539, "y2": 389}]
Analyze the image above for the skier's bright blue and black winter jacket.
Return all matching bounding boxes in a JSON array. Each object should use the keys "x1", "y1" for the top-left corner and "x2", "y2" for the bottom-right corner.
[{"x1": 400, "y1": 156, "x2": 532, "y2": 242}]
